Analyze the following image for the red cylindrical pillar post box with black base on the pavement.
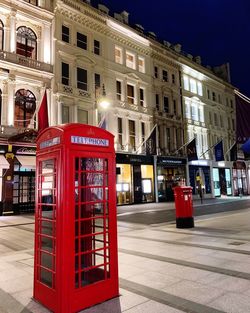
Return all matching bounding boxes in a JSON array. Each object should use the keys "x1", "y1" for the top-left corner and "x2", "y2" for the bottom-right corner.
[{"x1": 173, "y1": 186, "x2": 194, "y2": 228}]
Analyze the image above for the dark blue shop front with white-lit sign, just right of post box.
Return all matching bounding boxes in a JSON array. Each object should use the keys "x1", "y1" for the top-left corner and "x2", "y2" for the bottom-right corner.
[{"x1": 188, "y1": 160, "x2": 213, "y2": 198}]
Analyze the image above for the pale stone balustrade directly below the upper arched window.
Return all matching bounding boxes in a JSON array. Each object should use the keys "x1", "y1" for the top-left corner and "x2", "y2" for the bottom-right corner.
[{"x1": 0, "y1": 50, "x2": 53, "y2": 73}]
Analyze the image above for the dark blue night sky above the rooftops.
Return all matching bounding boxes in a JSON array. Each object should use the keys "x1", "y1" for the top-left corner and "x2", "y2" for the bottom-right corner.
[{"x1": 92, "y1": 0, "x2": 250, "y2": 97}]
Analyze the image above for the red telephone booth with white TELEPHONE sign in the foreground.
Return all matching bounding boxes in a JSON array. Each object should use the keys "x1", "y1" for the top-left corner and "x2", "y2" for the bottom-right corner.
[{"x1": 34, "y1": 124, "x2": 118, "y2": 313}]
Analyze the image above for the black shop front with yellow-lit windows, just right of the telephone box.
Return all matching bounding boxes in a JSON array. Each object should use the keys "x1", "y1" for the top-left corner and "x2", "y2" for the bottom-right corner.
[{"x1": 116, "y1": 153, "x2": 155, "y2": 205}]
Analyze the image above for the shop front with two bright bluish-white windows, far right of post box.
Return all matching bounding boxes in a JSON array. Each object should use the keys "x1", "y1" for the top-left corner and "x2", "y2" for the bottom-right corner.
[{"x1": 213, "y1": 161, "x2": 233, "y2": 197}]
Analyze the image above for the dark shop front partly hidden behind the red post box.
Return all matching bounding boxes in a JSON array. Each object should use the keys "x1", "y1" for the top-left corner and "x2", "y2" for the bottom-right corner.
[{"x1": 157, "y1": 156, "x2": 187, "y2": 202}]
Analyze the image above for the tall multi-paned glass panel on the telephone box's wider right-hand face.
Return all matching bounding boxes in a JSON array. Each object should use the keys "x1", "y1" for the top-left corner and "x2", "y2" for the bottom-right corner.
[{"x1": 74, "y1": 158, "x2": 109, "y2": 288}]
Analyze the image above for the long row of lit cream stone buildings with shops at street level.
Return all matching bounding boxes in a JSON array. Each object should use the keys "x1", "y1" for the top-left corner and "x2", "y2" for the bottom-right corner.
[{"x1": 0, "y1": 0, "x2": 243, "y2": 210}]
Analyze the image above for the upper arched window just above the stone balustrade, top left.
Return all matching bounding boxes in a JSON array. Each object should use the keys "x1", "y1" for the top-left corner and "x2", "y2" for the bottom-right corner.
[{"x1": 16, "y1": 26, "x2": 37, "y2": 59}]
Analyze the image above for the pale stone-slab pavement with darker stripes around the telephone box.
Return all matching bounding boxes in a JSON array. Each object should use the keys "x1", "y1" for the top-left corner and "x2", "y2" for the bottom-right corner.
[{"x1": 0, "y1": 209, "x2": 250, "y2": 313}]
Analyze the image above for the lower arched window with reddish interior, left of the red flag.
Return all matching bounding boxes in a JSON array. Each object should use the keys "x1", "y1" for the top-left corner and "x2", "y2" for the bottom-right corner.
[{"x1": 14, "y1": 89, "x2": 36, "y2": 128}]
